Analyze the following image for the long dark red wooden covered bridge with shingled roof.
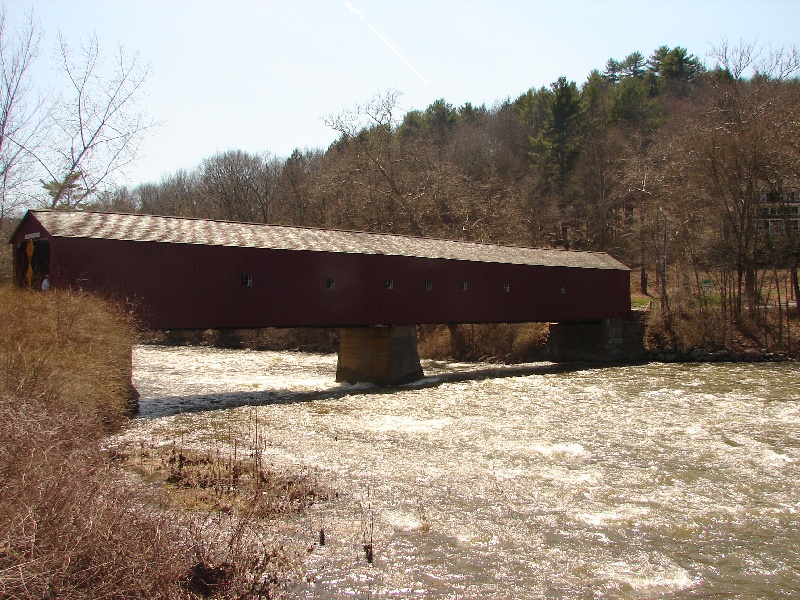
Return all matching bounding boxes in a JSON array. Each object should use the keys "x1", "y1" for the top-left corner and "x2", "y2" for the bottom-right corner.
[{"x1": 11, "y1": 210, "x2": 630, "y2": 380}]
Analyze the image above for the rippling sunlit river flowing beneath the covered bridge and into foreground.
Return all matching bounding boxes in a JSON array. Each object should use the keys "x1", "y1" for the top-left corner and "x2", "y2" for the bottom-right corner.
[{"x1": 126, "y1": 346, "x2": 800, "y2": 598}]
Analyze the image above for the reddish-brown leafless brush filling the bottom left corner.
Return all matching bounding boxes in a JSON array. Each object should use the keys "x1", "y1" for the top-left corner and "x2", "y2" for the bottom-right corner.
[{"x1": 0, "y1": 448, "x2": 188, "y2": 598}]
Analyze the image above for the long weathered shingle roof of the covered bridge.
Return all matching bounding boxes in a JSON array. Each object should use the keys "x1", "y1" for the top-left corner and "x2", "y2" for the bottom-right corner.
[{"x1": 29, "y1": 210, "x2": 628, "y2": 270}]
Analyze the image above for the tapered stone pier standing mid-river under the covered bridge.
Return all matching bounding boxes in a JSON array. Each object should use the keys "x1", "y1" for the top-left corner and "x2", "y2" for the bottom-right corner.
[{"x1": 336, "y1": 326, "x2": 424, "y2": 385}]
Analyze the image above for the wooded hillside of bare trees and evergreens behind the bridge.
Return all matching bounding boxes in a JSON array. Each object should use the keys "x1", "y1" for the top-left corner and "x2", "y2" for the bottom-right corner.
[{"x1": 86, "y1": 43, "x2": 800, "y2": 352}]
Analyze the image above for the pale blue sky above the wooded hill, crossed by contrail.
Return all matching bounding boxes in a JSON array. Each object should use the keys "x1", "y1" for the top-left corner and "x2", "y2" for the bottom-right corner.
[{"x1": 5, "y1": 0, "x2": 800, "y2": 185}]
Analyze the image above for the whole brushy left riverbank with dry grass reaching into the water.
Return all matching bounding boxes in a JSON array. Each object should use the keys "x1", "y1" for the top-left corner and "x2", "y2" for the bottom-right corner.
[{"x1": 0, "y1": 286, "x2": 317, "y2": 598}]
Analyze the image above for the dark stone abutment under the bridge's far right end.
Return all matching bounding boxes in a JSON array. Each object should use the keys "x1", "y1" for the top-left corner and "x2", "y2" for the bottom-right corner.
[{"x1": 548, "y1": 311, "x2": 644, "y2": 363}]
